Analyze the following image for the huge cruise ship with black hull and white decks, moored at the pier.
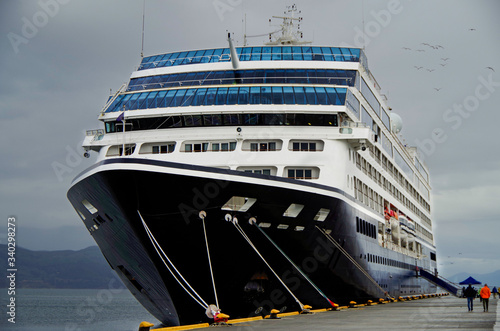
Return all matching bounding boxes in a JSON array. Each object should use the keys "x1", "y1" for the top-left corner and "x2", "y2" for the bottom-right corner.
[{"x1": 68, "y1": 6, "x2": 437, "y2": 326}]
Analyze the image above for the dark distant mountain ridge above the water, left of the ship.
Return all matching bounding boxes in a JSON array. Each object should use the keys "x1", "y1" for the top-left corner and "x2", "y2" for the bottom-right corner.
[{"x1": 0, "y1": 244, "x2": 119, "y2": 288}]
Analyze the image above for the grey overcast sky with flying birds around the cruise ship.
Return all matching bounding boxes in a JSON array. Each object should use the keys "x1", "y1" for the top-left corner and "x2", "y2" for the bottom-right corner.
[{"x1": 0, "y1": 0, "x2": 500, "y2": 276}]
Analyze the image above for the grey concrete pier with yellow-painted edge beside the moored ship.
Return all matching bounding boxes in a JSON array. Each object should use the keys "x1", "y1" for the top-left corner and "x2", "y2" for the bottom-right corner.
[{"x1": 155, "y1": 296, "x2": 500, "y2": 331}]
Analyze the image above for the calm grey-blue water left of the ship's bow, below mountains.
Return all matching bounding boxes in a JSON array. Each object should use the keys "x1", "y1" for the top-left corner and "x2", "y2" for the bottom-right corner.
[{"x1": 0, "y1": 288, "x2": 159, "y2": 331}]
